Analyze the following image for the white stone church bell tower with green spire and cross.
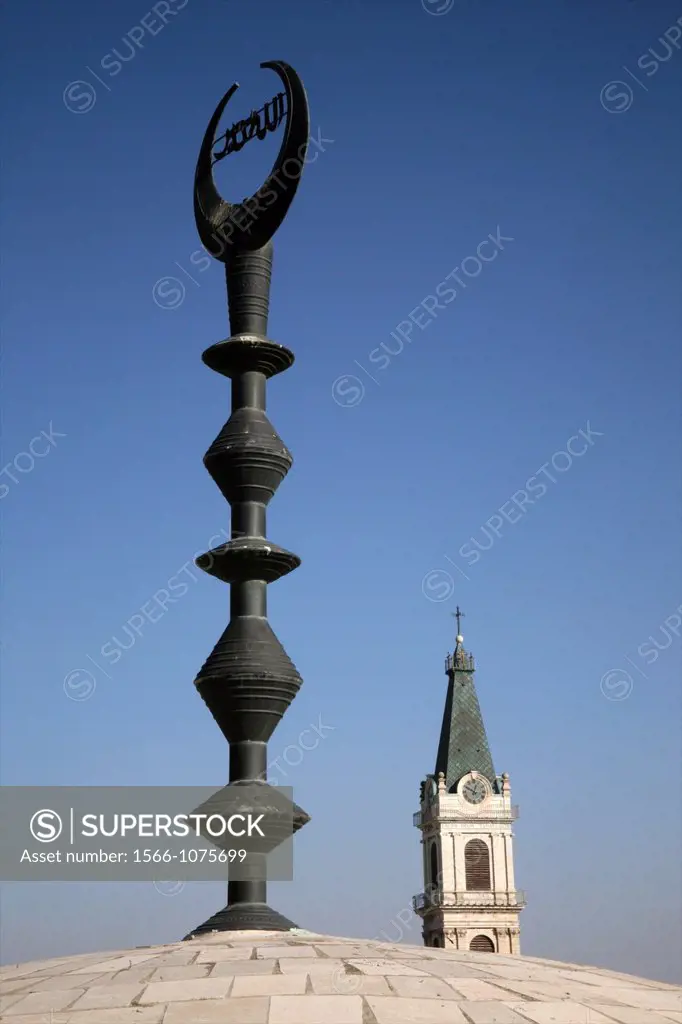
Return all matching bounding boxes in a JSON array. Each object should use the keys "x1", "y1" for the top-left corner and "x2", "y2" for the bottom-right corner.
[{"x1": 413, "y1": 607, "x2": 525, "y2": 953}]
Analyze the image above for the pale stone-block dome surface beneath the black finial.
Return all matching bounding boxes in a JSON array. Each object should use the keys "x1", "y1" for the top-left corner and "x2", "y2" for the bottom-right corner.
[{"x1": 0, "y1": 929, "x2": 682, "y2": 1024}]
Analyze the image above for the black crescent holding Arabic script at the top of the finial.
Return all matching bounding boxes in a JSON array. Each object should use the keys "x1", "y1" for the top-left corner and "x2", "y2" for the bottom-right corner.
[{"x1": 195, "y1": 60, "x2": 310, "y2": 263}]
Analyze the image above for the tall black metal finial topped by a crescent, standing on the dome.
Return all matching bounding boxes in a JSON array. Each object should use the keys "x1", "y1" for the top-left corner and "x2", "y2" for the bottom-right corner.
[{"x1": 187, "y1": 61, "x2": 309, "y2": 938}]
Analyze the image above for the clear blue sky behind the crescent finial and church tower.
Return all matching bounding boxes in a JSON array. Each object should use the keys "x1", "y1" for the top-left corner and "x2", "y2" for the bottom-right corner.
[{"x1": 0, "y1": 0, "x2": 682, "y2": 980}]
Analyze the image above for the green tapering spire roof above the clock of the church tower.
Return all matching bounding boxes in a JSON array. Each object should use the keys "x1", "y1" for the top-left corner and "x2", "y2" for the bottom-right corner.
[{"x1": 435, "y1": 630, "x2": 496, "y2": 793}]
